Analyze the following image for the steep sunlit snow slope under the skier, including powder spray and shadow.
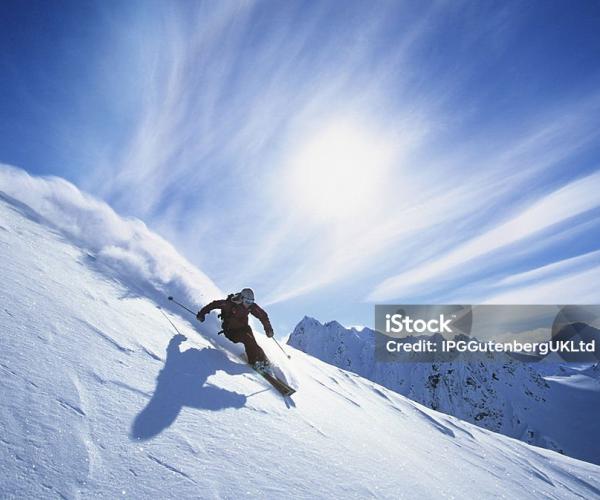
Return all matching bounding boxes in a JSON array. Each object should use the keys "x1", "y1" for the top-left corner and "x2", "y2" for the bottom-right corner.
[{"x1": 0, "y1": 168, "x2": 600, "y2": 499}]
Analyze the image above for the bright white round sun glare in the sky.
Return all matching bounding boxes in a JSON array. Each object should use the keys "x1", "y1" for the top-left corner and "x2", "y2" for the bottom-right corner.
[{"x1": 289, "y1": 121, "x2": 391, "y2": 219}]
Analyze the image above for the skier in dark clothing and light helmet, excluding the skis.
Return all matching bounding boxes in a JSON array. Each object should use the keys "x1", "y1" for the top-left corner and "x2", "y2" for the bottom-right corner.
[{"x1": 196, "y1": 288, "x2": 273, "y2": 368}]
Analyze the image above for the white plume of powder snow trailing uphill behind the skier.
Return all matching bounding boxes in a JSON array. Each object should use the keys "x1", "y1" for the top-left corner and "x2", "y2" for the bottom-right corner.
[{"x1": 0, "y1": 164, "x2": 222, "y2": 310}]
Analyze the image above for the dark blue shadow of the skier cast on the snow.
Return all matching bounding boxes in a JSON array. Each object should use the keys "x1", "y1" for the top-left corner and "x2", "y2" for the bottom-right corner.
[{"x1": 131, "y1": 335, "x2": 247, "y2": 440}]
